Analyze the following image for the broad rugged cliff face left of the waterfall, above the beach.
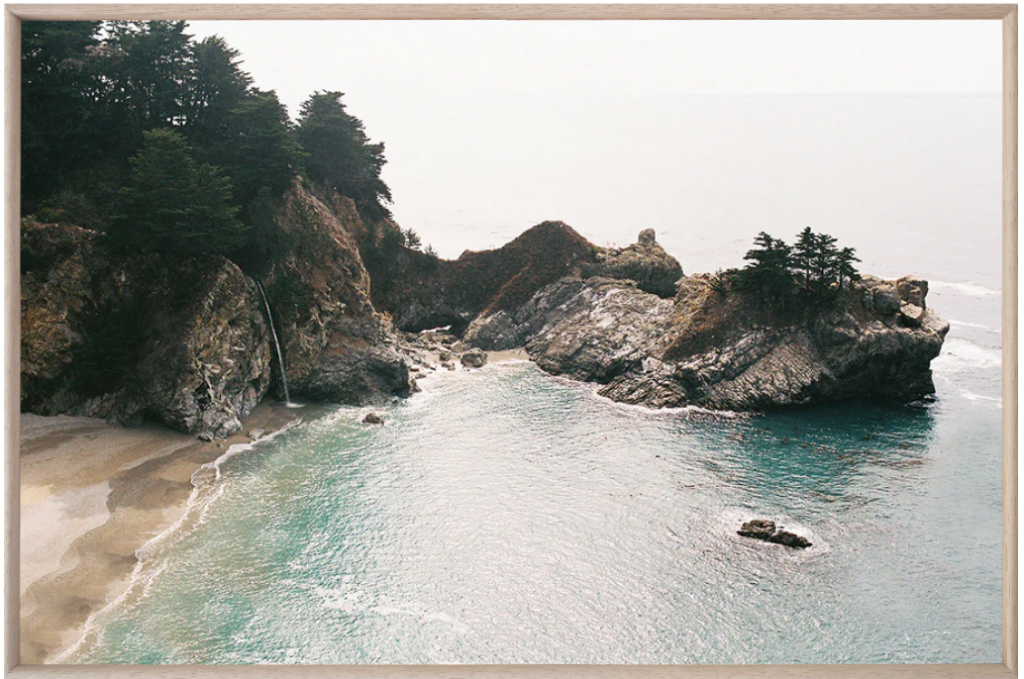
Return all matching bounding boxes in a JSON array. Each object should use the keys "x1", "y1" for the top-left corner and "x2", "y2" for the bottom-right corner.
[{"x1": 22, "y1": 222, "x2": 270, "y2": 436}]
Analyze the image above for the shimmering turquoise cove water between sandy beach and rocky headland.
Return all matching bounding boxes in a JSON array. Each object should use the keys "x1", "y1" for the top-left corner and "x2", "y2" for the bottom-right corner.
[{"x1": 62, "y1": 340, "x2": 1000, "y2": 664}]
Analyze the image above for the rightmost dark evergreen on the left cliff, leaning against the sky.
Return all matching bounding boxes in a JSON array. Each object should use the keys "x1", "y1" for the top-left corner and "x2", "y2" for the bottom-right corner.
[{"x1": 298, "y1": 92, "x2": 391, "y2": 220}]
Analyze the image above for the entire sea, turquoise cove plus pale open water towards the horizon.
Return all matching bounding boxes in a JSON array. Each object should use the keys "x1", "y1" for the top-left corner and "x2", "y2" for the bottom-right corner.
[{"x1": 57, "y1": 95, "x2": 1001, "y2": 664}]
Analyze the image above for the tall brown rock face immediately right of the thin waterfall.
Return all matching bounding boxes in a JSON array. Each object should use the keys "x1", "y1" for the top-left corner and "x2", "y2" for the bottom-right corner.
[{"x1": 263, "y1": 184, "x2": 412, "y2": 405}]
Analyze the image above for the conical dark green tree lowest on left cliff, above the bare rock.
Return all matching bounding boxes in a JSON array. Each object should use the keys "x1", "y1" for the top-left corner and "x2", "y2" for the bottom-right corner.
[{"x1": 108, "y1": 130, "x2": 248, "y2": 255}]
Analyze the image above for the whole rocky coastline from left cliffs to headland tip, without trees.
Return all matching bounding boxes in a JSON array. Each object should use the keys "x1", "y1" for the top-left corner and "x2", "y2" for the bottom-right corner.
[{"x1": 22, "y1": 204, "x2": 948, "y2": 436}]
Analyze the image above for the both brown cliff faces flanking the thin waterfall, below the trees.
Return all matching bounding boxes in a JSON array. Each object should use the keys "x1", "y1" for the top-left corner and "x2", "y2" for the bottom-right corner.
[{"x1": 22, "y1": 186, "x2": 412, "y2": 436}]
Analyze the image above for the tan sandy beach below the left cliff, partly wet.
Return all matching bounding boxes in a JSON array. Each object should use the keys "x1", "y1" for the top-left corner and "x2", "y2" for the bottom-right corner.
[{"x1": 19, "y1": 401, "x2": 300, "y2": 664}]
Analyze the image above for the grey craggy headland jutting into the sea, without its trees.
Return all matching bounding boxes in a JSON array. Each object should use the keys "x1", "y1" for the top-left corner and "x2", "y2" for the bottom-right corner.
[{"x1": 466, "y1": 266, "x2": 949, "y2": 411}]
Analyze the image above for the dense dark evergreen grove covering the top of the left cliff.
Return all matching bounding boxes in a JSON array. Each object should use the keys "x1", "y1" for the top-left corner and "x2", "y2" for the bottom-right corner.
[{"x1": 22, "y1": 22, "x2": 391, "y2": 260}]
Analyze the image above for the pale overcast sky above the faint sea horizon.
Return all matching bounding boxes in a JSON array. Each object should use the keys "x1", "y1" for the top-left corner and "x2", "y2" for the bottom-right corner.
[{"x1": 190, "y1": 20, "x2": 1001, "y2": 119}]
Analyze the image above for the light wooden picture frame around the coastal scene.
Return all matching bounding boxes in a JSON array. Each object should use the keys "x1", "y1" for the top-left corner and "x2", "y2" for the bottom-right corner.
[{"x1": 4, "y1": 4, "x2": 1018, "y2": 679}]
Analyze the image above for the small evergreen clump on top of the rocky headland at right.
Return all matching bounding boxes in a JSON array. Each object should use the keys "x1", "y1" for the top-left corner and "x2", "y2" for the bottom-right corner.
[{"x1": 733, "y1": 226, "x2": 860, "y2": 306}]
